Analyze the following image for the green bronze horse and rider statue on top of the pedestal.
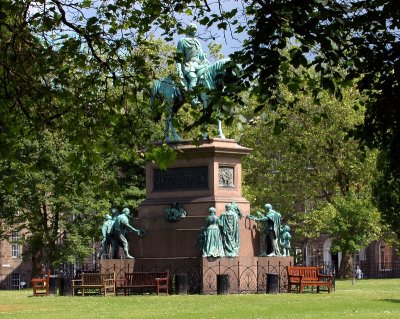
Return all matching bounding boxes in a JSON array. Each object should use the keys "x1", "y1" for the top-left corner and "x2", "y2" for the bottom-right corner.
[{"x1": 150, "y1": 24, "x2": 238, "y2": 141}]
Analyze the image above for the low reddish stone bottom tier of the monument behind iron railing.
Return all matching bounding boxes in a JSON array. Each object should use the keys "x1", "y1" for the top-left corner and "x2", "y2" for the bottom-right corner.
[{"x1": 100, "y1": 257, "x2": 294, "y2": 294}]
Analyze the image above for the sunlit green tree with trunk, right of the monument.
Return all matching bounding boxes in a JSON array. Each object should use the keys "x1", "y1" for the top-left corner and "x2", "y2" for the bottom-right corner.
[{"x1": 240, "y1": 65, "x2": 380, "y2": 274}]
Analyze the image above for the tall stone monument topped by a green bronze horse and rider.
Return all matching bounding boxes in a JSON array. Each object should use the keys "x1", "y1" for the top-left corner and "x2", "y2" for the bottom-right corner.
[{"x1": 101, "y1": 26, "x2": 293, "y2": 293}]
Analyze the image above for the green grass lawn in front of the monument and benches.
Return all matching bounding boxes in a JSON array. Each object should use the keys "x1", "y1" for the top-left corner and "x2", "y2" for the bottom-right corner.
[{"x1": 0, "y1": 279, "x2": 400, "y2": 319}]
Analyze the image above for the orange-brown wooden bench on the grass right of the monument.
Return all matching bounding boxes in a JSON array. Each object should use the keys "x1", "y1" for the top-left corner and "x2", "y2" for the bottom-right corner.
[{"x1": 287, "y1": 266, "x2": 333, "y2": 293}]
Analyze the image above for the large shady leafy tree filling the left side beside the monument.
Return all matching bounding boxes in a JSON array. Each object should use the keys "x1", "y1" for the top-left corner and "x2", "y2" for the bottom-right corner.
[{"x1": 0, "y1": 1, "x2": 174, "y2": 271}]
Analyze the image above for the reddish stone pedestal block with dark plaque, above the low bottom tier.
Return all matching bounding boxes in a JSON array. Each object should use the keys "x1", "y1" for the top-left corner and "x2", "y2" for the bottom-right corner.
[{"x1": 130, "y1": 139, "x2": 260, "y2": 258}]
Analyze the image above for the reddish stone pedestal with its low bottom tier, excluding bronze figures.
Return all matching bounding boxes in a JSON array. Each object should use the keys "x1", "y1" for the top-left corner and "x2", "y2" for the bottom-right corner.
[{"x1": 111, "y1": 138, "x2": 293, "y2": 293}]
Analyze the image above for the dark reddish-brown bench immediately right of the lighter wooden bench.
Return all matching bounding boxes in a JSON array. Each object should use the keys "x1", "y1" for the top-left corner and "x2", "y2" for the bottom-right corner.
[{"x1": 116, "y1": 271, "x2": 169, "y2": 295}]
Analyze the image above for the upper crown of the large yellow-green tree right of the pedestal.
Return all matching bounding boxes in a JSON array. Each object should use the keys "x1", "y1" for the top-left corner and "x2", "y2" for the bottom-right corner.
[{"x1": 240, "y1": 65, "x2": 375, "y2": 212}]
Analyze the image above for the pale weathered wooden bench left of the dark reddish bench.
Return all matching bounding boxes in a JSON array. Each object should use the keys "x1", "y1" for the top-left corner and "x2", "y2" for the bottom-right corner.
[{"x1": 72, "y1": 272, "x2": 115, "y2": 296}]
